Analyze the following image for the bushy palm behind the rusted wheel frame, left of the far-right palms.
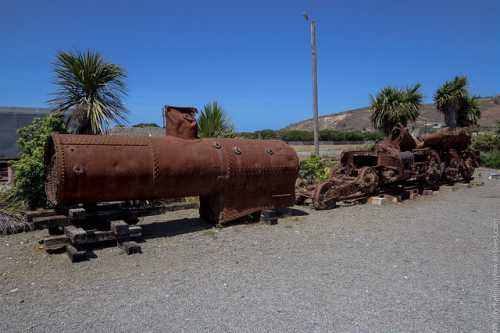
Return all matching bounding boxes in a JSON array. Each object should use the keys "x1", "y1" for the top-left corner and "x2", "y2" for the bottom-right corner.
[{"x1": 370, "y1": 83, "x2": 422, "y2": 136}]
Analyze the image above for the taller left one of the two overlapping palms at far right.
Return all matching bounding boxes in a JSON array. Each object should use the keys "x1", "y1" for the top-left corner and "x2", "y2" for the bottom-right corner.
[{"x1": 434, "y1": 76, "x2": 469, "y2": 128}]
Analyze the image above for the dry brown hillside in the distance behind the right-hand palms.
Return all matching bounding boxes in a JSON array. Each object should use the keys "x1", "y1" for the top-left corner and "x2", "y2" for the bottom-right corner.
[{"x1": 285, "y1": 97, "x2": 500, "y2": 131}]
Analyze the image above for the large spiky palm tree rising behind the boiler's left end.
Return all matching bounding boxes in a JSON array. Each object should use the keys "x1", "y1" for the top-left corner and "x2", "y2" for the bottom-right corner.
[{"x1": 50, "y1": 51, "x2": 127, "y2": 134}]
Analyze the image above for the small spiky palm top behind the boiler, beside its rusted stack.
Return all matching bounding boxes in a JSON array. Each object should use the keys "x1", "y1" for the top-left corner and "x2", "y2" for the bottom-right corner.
[{"x1": 198, "y1": 102, "x2": 234, "y2": 138}]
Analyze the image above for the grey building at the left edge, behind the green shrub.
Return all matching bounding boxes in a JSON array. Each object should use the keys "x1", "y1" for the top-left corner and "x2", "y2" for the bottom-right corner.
[{"x1": 0, "y1": 107, "x2": 50, "y2": 160}]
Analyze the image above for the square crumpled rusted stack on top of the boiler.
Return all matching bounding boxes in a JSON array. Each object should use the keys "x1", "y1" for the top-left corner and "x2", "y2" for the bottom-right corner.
[{"x1": 163, "y1": 105, "x2": 198, "y2": 139}]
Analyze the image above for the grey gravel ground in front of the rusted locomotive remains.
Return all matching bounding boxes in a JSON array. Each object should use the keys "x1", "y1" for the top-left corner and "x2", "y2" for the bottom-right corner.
[{"x1": 0, "y1": 170, "x2": 500, "y2": 332}]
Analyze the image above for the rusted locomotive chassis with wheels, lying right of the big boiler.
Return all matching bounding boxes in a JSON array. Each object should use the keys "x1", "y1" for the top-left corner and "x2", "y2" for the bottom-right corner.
[{"x1": 297, "y1": 127, "x2": 479, "y2": 209}]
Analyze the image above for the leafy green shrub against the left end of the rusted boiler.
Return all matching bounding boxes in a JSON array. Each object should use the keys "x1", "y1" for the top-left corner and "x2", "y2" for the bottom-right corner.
[{"x1": 9, "y1": 114, "x2": 66, "y2": 208}]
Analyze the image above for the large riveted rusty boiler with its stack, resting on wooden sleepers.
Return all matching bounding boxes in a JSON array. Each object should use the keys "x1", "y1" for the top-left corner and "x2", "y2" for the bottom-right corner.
[{"x1": 45, "y1": 107, "x2": 298, "y2": 223}]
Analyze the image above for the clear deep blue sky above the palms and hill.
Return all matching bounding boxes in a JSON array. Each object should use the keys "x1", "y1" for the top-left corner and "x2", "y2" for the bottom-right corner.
[{"x1": 0, "y1": 0, "x2": 500, "y2": 130}]
